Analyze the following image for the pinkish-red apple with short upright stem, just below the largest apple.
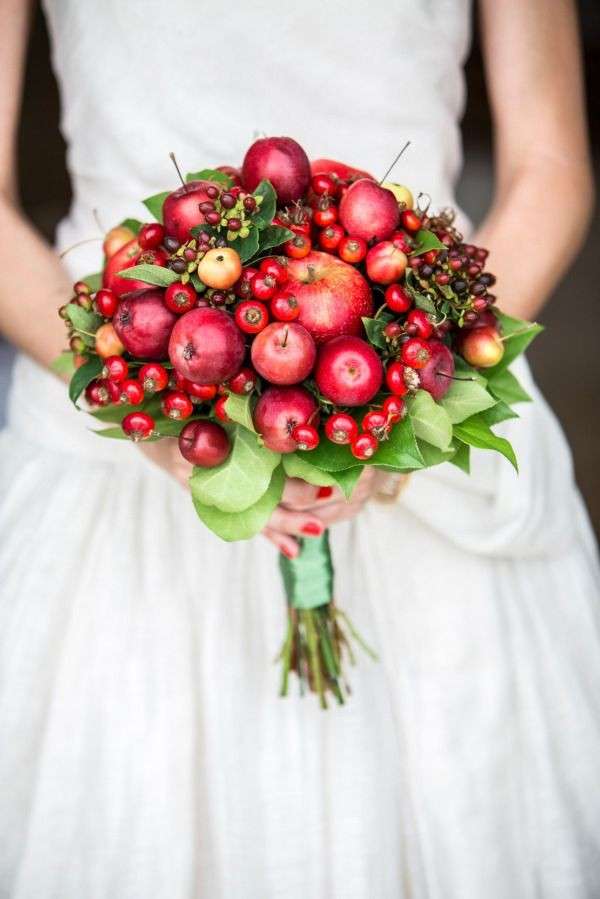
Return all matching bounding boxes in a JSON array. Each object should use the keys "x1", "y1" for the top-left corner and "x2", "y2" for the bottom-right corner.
[{"x1": 252, "y1": 322, "x2": 317, "y2": 384}]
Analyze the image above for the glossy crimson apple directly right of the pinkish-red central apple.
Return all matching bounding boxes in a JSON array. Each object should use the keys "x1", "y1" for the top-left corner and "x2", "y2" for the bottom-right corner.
[{"x1": 314, "y1": 336, "x2": 383, "y2": 406}]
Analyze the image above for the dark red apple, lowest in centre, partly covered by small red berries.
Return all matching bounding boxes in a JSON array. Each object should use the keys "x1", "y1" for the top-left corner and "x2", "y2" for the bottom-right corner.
[{"x1": 254, "y1": 387, "x2": 317, "y2": 453}]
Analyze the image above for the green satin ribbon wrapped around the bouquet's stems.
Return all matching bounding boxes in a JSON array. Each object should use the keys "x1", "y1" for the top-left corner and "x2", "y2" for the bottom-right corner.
[{"x1": 279, "y1": 531, "x2": 333, "y2": 609}]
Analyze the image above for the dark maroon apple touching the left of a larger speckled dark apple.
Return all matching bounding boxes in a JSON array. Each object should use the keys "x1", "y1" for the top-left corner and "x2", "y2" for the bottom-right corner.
[{"x1": 113, "y1": 282, "x2": 178, "y2": 359}]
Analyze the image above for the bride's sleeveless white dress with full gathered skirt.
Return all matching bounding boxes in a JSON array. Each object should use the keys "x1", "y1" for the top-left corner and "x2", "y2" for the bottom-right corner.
[{"x1": 0, "y1": 0, "x2": 600, "y2": 899}]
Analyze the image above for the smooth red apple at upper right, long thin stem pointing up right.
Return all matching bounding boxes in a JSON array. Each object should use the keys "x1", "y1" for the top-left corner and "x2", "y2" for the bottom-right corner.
[{"x1": 339, "y1": 178, "x2": 400, "y2": 240}]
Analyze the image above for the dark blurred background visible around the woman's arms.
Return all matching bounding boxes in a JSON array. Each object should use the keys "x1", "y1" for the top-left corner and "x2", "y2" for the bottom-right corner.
[{"x1": 0, "y1": 0, "x2": 600, "y2": 534}]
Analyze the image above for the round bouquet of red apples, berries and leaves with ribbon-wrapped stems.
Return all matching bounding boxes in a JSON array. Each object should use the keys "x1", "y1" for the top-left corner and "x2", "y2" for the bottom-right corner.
[{"x1": 56, "y1": 137, "x2": 540, "y2": 706}]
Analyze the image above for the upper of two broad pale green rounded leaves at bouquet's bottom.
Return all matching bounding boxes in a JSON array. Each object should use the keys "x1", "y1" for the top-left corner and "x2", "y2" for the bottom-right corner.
[{"x1": 190, "y1": 425, "x2": 280, "y2": 512}]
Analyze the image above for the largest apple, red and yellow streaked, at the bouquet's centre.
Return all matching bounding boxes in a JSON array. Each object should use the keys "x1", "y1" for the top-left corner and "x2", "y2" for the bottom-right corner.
[{"x1": 285, "y1": 251, "x2": 373, "y2": 343}]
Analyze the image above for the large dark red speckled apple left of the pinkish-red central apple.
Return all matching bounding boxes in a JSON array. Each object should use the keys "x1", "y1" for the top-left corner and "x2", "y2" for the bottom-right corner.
[{"x1": 169, "y1": 306, "x2": 245, "y2": 384}]
